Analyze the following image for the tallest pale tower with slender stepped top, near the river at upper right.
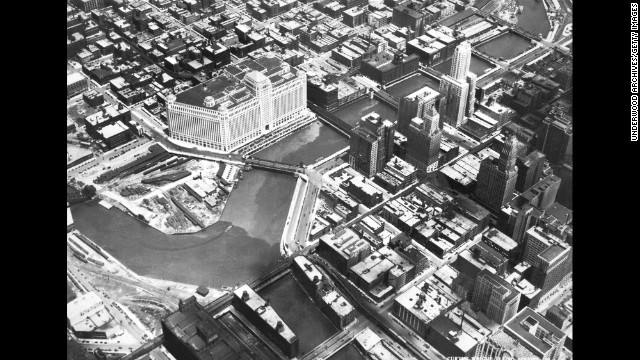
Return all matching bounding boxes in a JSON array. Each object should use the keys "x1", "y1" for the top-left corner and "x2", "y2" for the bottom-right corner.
[{"x1": 440, "y1": 41, "x2": 477, "y2": 128}]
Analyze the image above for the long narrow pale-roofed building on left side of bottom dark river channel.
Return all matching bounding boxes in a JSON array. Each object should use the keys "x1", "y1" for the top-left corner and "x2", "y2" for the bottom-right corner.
[{"x1": 232, "y1": 284, "x2": 300, "y2": 357}]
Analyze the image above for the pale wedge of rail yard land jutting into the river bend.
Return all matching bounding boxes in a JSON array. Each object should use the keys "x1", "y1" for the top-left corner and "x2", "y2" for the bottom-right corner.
[{"x1": 70, "y1": 147, "x2": 242, "y2": 235}]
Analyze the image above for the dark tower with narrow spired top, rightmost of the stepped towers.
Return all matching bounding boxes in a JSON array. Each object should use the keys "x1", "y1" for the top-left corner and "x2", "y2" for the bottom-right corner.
[{"x1": 475, "y1": 135, "x2": 521, "y2": 213}]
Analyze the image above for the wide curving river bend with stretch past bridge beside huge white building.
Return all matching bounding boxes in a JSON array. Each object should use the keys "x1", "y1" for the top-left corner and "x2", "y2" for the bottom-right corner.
[{"x1": 71, "y1": 122, "x2": 348, "y2": 288}]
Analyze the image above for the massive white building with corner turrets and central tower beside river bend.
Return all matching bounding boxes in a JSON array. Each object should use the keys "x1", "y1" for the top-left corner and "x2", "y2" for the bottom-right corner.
[{"x1": 167, "y1": 54, "x2": 313, "y2": 152}]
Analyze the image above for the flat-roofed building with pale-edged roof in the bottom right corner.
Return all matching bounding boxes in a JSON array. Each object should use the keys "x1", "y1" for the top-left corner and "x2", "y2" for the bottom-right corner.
[{"x1": 504, "y1": 307, "x2": 567, "y2": 360}]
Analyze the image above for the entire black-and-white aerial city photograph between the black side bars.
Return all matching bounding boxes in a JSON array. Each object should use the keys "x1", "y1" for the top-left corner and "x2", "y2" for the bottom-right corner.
[{"x1": 66, "y1": 0, "x2": 573, "y2": 360}]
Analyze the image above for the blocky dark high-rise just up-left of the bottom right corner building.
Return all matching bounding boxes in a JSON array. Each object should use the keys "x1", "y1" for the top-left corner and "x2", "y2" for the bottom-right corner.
[{"x1": 472, "y1": 269, "x2": 520, "y2": 325}]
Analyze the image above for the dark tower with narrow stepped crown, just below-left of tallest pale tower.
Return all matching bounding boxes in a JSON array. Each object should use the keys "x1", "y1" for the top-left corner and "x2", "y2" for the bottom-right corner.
[{"x1": 406, "y1": 107, "x2": 442, "y2": 172}]
